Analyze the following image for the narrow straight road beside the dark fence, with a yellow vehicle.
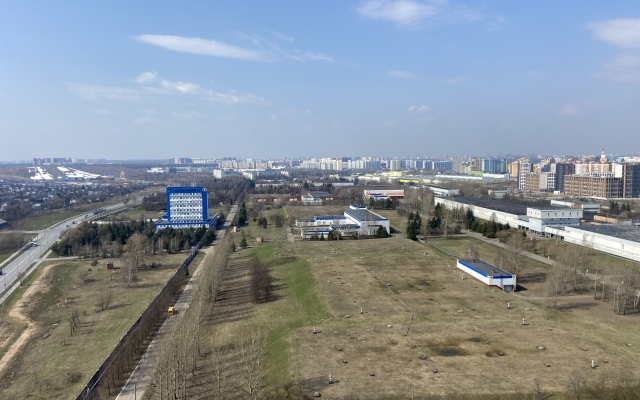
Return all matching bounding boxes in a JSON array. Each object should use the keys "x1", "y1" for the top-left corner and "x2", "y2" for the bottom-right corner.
[{"x1": 116, "y1": 206, "x2": 238, "y2": 400}]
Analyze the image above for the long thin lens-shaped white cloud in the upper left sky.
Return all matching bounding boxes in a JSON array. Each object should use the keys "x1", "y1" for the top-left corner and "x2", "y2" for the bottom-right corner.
[{"x1": 133, "y1": 35, "x2": 270, "y2": 61}]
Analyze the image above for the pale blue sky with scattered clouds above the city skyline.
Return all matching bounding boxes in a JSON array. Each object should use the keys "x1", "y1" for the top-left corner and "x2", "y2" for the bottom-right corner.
[{"x1": 0, "y1": 0, "x2": 640, "y2": 161}]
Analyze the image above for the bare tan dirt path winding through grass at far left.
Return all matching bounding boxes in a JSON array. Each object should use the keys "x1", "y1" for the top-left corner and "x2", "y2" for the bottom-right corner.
[{"x1": 0, "y1": 265, "x2": 54, "y2": 376}]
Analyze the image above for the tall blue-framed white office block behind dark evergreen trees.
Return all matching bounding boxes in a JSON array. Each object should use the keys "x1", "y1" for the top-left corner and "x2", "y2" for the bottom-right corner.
[{"x1": 155, "y1": 186, "x2": 218, "y2": 229}]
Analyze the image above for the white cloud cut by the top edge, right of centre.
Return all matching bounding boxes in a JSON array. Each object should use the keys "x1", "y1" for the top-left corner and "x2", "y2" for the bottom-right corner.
[{"x1": 358, "y1": 0, "x2": 439, "y2": 25}]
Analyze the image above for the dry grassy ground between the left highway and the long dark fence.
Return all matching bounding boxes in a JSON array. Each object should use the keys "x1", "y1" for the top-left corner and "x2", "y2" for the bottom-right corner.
[{"x1": 0, "y1": 254, "x2": 192, "y2": 399}]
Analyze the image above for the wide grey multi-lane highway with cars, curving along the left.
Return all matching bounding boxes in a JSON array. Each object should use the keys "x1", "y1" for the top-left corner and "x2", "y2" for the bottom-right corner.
[{"x1": 0, "y1": 202, "x2": 132, "y2": 304}]
